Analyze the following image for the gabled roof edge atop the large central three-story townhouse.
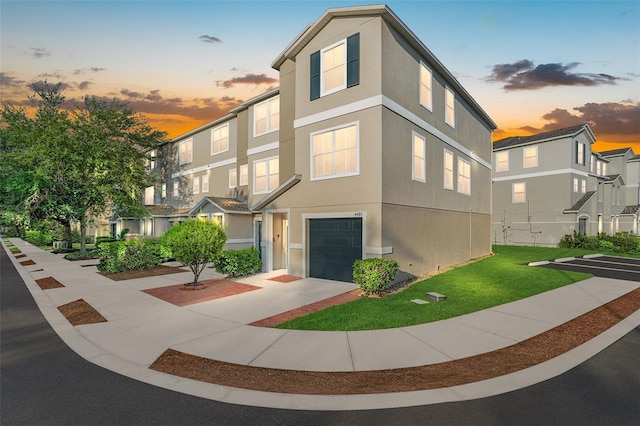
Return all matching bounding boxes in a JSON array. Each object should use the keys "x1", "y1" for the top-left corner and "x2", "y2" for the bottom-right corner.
[{"x1": 271, "y1": 4, "x2": 498, "y2": 129}]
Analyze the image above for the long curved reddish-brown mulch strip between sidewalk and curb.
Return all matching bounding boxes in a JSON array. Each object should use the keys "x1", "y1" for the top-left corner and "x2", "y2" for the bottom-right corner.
[{"x1": 149, "y1": 289, "x2": 640, "y2": 395}]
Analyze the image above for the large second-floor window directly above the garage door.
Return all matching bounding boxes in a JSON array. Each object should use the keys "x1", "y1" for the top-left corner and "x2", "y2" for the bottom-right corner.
[{"x1": 311, "y1": 124, "x2": 359, "y2": 180}]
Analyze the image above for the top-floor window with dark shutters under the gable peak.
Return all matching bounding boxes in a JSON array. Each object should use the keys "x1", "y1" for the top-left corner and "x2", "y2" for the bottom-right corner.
[{"x1": 310, "y1": 33, "x2": 360, "y2": 100}]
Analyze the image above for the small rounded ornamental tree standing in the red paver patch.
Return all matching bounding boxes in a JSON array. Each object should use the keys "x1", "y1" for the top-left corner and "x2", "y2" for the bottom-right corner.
[{"x1": 162, "y1": 220, "x2": 227, "y2": 286}]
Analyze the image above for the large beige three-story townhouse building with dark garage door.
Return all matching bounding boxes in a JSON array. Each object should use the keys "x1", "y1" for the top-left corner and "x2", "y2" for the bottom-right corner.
[{"x1": 110, "y1": 5, "x2": 496, "y2": 281}]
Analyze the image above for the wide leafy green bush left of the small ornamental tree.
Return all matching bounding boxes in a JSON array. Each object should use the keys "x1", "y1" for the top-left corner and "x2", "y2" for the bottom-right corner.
[{"x1": 97, "y1": 240, "x2": 163, "y2": 272}]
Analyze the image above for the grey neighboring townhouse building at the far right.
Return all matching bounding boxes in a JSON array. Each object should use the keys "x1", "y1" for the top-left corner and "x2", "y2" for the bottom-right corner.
[{"x1": 493, "y1": 124, "x2": 640, "y2": 246}]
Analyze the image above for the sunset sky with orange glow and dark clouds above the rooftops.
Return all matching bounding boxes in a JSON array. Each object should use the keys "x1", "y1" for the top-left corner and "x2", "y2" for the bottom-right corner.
[{"x1": 0, "y1": 0, "x2": 640, "y2": 154}]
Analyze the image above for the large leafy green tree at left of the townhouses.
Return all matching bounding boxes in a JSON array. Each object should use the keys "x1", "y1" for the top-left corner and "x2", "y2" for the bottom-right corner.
[{"x1": 0, "y1": 85, "x2": 165, "y2": 250}]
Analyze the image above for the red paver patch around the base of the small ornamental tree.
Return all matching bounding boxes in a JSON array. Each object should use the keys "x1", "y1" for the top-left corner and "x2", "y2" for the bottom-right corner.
[{"x1": 143, "y1": 279, "x2": 262, "y2": 306}]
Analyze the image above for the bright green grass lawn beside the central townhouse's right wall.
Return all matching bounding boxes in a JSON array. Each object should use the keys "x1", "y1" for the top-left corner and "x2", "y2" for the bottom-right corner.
[{"x1": 278, "y1": 246, "x2": 594, "y2": 331}]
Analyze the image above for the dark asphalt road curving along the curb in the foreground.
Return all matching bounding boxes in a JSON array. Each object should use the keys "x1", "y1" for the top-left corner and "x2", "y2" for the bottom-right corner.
[{"x1": 0, "y1": 245, "x2": 640, "y2": 426}]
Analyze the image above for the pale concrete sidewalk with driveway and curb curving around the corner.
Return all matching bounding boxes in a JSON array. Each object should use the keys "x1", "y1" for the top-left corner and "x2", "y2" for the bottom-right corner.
[{"x1": 3, "y1": 239, "x2": 640, "y2": 410}]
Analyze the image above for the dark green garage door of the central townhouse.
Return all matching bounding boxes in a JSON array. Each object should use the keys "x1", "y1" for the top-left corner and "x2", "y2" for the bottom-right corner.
[{"x1": 309, "y1": 218, "x2": 362, "y2": 282}]
